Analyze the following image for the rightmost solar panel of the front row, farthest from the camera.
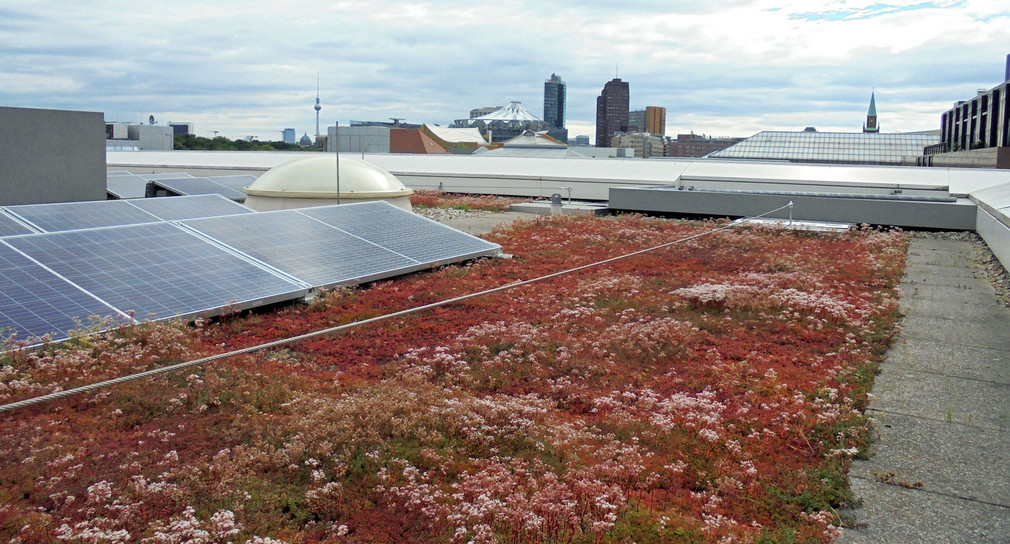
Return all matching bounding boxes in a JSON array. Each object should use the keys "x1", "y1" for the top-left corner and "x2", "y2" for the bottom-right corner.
[{"x1": 298, "y1": 201, "x2": 501, "y2": 264}]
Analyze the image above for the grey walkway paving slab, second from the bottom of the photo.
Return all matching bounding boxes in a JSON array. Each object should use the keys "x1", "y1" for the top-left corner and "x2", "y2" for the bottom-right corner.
[{"x1": 850, "y1": 413, "x2": 1010, "y2": 506}]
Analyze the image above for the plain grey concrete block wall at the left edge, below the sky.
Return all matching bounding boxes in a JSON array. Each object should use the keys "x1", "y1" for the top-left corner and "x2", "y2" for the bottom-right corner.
[{"x1": 0, "y1": 107, "x2": 105, "y2": 205}]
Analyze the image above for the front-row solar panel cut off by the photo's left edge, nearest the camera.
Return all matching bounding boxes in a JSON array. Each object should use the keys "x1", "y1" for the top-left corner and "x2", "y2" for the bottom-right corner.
[{"x1": 0, "y1": 242, "x2": 126, "y2": 340}]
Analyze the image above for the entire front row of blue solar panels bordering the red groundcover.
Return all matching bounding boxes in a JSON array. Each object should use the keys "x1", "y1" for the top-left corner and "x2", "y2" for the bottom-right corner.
[{"x1": 0, "y1": 196, "x2": 501, "y2": 340}]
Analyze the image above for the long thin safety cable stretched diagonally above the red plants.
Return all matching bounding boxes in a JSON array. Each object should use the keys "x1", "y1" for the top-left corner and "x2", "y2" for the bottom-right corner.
[{"x1": 0, "y1": 201, "x2": 793, "y2": 413}]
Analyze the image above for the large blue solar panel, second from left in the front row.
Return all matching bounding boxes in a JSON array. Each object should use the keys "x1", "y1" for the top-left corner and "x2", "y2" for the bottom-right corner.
[{"x1": 5, "y1": 223, "x2": 307, "y2": 319}]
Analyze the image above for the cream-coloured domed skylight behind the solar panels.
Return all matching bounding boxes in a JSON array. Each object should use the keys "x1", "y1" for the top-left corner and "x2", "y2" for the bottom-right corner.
[{"x1": 243, "y1": 153, "x2": 414, "y2": 211}]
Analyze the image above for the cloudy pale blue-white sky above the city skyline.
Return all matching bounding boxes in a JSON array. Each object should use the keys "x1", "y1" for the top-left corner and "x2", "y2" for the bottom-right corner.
[{"x1": 0, "y1": 0, "x2": 1010, "y2": 139}]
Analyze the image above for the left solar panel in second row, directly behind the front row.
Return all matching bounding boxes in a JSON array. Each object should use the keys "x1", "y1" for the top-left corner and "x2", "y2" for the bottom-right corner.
[{"x1": 7, "y1": 200, "x2": 159, "y2": 232}]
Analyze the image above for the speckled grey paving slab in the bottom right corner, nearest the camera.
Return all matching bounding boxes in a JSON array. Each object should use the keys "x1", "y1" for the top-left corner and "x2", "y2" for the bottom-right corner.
[{"x1": 835, "y1": 477, "x2": 1010, "y2": 544}]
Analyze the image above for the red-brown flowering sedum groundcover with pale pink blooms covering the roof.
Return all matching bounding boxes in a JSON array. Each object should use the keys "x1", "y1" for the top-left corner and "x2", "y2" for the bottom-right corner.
[{"x1": 0, "y1": 211, "x2": 906, "y2": 543}]
